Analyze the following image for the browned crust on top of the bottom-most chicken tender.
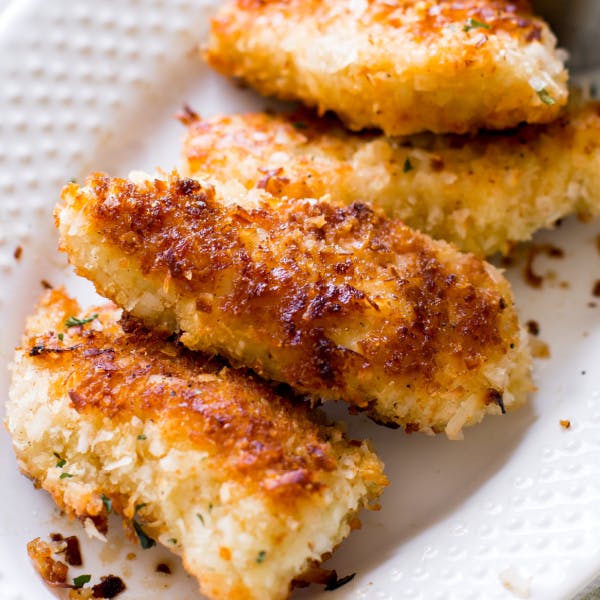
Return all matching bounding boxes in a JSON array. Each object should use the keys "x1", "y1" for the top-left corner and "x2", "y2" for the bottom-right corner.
[{"x1": 24, "y1": 290, "x2": 356, "y2": 497}]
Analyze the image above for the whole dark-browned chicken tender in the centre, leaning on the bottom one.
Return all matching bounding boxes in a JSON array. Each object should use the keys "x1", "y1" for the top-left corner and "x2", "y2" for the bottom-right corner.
[{"x1": 55, "y1": 174, "x2": 531, "y2": 438}]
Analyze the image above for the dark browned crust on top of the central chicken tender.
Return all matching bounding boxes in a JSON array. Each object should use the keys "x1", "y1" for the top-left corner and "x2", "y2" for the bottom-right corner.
[{"x1": 65, "y1": 174, "x2": 518, "y2": 406}]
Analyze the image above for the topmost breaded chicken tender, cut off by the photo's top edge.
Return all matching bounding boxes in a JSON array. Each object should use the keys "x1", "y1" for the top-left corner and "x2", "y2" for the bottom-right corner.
[{"x1": 205, "y1": 0, "x2": 568, "y2": 135}]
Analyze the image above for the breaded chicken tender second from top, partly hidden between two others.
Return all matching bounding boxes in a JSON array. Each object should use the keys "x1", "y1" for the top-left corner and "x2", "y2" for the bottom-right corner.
[{"x1": 184, "y1": 102, "x2": 600, "y2": 255}]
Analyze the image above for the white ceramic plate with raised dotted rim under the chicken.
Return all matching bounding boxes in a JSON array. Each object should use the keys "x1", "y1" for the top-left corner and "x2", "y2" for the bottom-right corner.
[{"x1": 0, "y1": 0, "x2": 600, "y2": 600}]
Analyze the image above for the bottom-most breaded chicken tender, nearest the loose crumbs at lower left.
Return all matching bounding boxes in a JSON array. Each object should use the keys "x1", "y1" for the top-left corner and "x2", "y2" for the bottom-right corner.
[{"x1": 6, "y1": 290, "x2": 387, "y2": 600}]
